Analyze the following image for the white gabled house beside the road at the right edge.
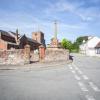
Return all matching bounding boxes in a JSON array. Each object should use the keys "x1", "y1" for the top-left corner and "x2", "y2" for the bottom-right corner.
[{"x1": 80, "y1": 37, "x2": 100, "y2": 56}]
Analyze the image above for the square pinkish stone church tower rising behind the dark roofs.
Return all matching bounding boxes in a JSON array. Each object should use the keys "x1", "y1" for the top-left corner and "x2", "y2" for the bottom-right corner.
[{"x1": 32, "y1": 31, "x2": 46, "y2": 47}]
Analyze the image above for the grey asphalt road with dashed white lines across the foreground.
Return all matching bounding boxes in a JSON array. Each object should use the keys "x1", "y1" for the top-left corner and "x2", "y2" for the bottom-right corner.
[{"x1": 0, "y1": 54, "x2": 100, "y2": 100}]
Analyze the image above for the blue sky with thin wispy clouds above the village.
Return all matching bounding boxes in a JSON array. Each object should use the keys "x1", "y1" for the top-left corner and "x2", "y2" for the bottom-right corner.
[{"x1": 0, "y1": 0, "x2": 100, "y2": 43}]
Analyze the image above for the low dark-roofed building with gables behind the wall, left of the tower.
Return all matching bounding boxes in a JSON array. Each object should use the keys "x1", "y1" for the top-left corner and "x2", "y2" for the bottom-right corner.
[{"x1": 0, "y1": 30, "x2": 41, "y2": 50}]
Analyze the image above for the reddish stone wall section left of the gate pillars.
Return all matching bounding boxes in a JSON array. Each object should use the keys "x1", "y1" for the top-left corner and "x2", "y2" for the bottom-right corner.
[{"x1": 0, "y1": 49, "x2": 24, "y2": 65}]
